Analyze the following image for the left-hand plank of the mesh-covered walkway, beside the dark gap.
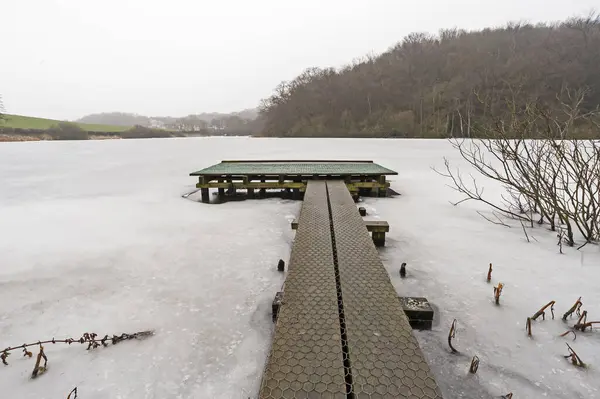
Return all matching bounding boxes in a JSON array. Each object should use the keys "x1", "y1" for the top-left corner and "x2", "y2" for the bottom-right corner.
[{"x1": 260, "y1": 181, "x2": 346, "y2": 399}]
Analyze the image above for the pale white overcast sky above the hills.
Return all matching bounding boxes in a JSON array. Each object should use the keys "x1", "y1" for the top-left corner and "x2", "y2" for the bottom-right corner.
[{"x1": 0, "y1": 0, "x2": 598, "y2": 119}]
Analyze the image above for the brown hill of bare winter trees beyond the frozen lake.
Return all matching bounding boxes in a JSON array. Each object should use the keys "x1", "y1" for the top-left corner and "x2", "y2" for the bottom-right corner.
[{"x1": 261, "y1": 15, "x2": 600, "y2": 137}]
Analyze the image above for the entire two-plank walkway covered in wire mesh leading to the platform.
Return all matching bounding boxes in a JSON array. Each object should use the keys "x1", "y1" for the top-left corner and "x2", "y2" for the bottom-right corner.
[{"x1": 260, "y1": 180, "x2": 442, "y2": 399}]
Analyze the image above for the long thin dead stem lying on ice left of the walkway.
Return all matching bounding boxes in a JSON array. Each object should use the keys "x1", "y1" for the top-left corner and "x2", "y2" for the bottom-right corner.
[{"x1": 0, "y1": 330, "x2": 154, "y2": 380}]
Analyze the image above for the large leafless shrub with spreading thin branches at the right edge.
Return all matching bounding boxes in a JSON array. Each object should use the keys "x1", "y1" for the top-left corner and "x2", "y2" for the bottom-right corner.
[{"x1": 438, "y1": 88, "x2": 600, "y2": 248}]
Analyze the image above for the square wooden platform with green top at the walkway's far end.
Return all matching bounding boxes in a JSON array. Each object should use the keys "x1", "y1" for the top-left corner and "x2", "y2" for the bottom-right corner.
[{"x1": 190, "y1": 160, "x2": 397, "y2": 203}]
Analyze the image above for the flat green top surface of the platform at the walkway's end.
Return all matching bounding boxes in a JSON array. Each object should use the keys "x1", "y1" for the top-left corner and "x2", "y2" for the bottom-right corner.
[{"x1": 190, "y1": 161, "x2": 398, "y2": 176}]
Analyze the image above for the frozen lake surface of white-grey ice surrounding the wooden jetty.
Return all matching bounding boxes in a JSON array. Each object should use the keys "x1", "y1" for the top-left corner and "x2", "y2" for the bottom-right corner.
[{"x1": 0, "y1": 138, "x2": 600, "y2": 399}]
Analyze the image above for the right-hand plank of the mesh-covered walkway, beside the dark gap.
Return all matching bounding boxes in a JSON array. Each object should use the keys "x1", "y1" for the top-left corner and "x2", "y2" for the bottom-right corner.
[{"x1": 327, "y1": 181, "x2": 441, "y2": 398}]
